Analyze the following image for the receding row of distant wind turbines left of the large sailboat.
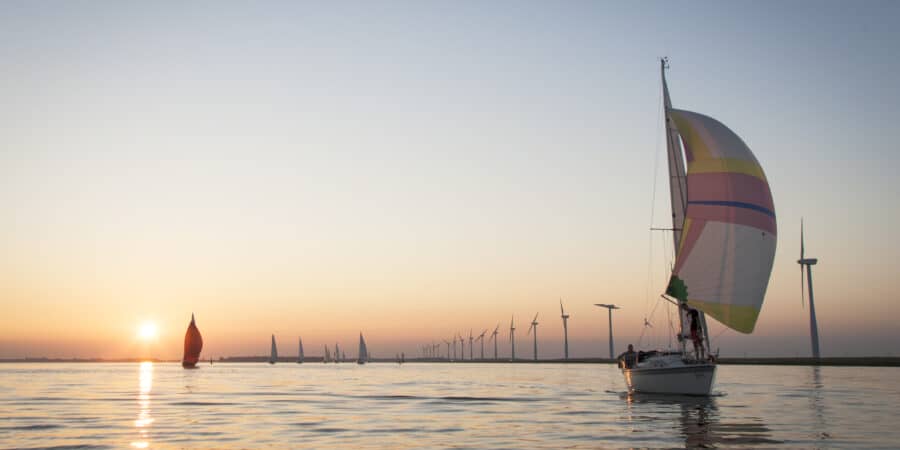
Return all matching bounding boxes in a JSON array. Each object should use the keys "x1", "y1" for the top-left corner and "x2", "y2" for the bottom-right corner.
[{"x1": 419, "y1": 300, "x2": 620, "y2": 361}]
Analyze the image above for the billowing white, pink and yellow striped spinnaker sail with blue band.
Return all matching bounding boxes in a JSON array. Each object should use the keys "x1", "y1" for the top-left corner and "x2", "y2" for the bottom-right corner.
[{"x1": 668, "y1": 109, "x2": 777, "y2": 333}]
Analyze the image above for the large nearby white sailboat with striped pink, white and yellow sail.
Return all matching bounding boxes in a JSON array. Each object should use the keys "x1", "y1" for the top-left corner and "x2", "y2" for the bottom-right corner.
[{"x1": 622, "y1": 58, "x2": 777, "y2": 395}]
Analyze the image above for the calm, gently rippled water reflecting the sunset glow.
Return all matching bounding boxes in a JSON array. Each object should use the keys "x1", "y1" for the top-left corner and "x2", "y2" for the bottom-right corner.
[{"x1": 0, "y1": 363, "x2": 900, "y2": 448}]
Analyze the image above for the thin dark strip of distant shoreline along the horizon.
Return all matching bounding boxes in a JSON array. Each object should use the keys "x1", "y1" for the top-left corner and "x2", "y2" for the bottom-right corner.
[{"x1": 0, "y1": 356, "x2": 900, "y2": 367}]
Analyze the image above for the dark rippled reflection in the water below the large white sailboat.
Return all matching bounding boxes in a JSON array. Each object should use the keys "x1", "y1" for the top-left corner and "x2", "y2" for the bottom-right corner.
[{"x1": 627, "y1": 393, "x2": 781, "y2": 448}]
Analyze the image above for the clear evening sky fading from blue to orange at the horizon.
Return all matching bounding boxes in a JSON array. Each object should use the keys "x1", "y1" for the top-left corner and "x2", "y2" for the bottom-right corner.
[{"x1": 0, "y1": 1, "x2": 900, "y2": 358}]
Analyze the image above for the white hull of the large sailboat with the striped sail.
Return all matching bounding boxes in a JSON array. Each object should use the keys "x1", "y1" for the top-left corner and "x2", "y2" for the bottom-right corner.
[{"x1": 622, "y1": 356, "x2": 716, "y2": 396}]
